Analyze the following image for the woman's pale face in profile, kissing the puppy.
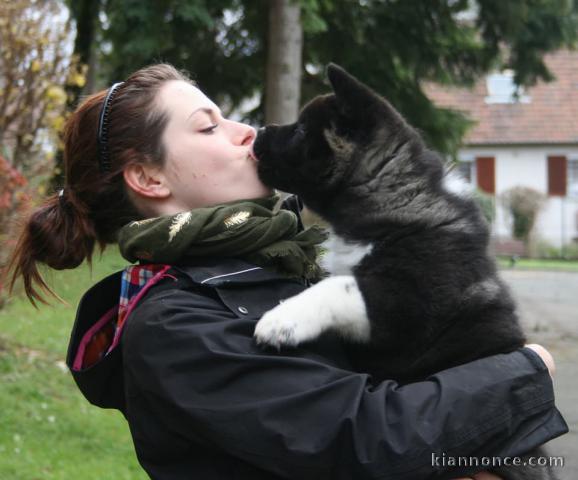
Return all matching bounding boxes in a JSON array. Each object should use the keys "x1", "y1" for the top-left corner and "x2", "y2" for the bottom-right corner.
[{"x1": 157, "y1": 80, "x2": 272, "y2": 211}]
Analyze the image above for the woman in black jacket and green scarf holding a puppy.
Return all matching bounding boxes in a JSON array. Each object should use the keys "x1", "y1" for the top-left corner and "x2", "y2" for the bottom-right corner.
[{"x1": 6, "y1": 65, "x2": 566, "y2": 480}]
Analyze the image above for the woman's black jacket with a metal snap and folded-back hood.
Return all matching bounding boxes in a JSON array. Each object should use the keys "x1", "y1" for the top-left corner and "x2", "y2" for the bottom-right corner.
[{"x1": 68, "y1": 200, "x2": 567, "y2": 480}]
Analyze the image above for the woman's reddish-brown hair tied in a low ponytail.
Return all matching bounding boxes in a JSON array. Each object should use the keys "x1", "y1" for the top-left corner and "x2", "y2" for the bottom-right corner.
[{"x1": 7, "y1": 64, "x2": 193, "y2": 305}]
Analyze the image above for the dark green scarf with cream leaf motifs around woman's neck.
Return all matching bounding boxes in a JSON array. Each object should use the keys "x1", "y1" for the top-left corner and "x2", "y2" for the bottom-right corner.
[{"x1": 118, "y1": 193, "x2": 328, "y2": 282}]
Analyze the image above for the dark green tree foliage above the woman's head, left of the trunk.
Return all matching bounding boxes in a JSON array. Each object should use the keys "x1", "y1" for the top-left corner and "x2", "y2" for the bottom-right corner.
[{"x1": 102, "y1": 0, "x2": 267, "y2": 113}]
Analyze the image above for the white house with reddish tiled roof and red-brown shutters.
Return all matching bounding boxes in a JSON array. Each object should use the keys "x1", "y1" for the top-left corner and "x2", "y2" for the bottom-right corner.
[{"x1": 425, "y1": 51, "x2": 578, "y2": 248}]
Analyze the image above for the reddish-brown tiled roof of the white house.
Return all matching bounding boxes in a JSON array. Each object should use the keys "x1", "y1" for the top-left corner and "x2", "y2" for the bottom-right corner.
[{"x1": 425, "y1": 50, "x2": 578, "y2": 145}]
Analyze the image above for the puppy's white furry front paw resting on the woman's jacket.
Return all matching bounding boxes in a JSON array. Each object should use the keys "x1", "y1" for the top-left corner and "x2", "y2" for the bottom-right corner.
[{"x1": 254, "y1": 300, "x2": 321, "y2": 350}]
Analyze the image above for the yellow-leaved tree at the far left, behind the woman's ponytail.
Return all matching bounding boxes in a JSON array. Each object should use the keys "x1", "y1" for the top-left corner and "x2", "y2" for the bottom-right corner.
[{"x1": 0, "y1": 0, "x2": 74, "y2": 171}]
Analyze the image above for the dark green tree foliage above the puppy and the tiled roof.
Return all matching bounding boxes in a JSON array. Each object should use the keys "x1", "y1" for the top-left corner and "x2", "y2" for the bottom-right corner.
[{"x1": 296, "y1": 0, "x2": 578, "y2": 153}]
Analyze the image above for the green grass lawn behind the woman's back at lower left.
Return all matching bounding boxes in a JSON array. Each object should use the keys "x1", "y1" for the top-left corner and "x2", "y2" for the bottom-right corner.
[{"x1": 0, "y1": 250, "x2": 148, "y2": 480}]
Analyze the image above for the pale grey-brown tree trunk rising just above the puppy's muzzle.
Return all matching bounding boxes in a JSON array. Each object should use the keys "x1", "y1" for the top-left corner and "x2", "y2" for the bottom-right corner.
[{"x1": 265, "y1": 0, "x2": 303, "y2": 124}]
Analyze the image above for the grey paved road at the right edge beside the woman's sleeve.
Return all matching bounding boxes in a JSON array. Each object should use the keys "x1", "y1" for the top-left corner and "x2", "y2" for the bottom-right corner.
[{"x1": 502, "y1": 270, "x2": 578, "y2": 480}]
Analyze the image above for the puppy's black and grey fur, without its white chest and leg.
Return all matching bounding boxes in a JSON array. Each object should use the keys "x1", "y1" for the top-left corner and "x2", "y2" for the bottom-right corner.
[{"x1": 254, "y1": 65, "x2": 554, "y2": 479}]
